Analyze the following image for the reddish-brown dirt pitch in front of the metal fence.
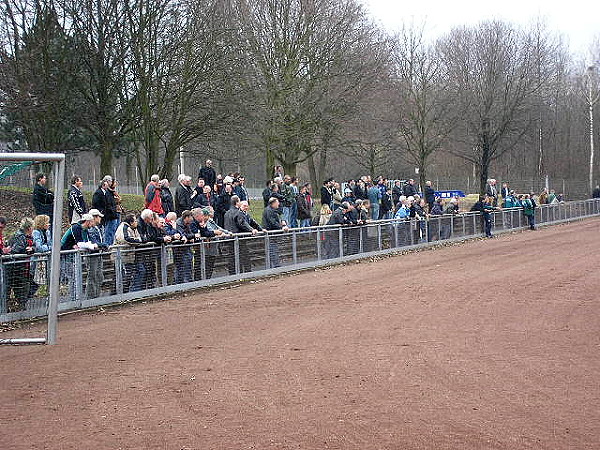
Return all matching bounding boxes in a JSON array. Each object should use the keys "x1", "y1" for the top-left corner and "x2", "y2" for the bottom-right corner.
[{"x1": 0, "y1": 220, "x2": 600, "y2": 450}]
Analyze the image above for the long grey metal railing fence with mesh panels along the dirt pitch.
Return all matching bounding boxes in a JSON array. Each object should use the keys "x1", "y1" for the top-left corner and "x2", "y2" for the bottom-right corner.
[{"x1": 0, "y1": 200, "x2": 600, "y2": 323}]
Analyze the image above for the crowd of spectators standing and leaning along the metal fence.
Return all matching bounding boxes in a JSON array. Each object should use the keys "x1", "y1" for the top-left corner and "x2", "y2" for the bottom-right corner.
[{"x1": 0, "y1": 160, "x2": 576, "y2": 308}]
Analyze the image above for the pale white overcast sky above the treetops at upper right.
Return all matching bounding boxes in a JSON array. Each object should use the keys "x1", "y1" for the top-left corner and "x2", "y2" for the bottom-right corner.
[{"x1": 363, "y1": 0, "x2": 600, "y2": 59}]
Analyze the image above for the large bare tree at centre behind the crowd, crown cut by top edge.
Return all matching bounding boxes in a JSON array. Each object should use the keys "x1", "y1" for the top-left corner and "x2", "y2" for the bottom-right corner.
[{"x1": 236, "y1": 0, "x2": 386, "y2": 179}]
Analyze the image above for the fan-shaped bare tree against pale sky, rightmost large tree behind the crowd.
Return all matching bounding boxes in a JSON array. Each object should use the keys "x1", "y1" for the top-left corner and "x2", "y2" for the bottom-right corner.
[{"x1": 438, "y1": 21, "x2": 546, "y2": 193}]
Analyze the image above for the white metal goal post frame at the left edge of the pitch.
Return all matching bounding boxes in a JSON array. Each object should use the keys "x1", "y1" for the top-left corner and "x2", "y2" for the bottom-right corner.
[{"x1": 0, "y1": 153, "x2": 65, "y2": 345}]
